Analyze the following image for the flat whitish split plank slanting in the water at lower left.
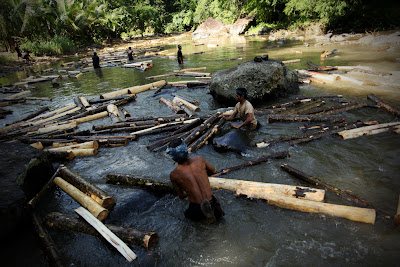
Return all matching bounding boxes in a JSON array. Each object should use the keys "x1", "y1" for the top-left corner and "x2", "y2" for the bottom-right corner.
[{"x1": 75, "y1": 207, "x2": 136, "y2": 262}]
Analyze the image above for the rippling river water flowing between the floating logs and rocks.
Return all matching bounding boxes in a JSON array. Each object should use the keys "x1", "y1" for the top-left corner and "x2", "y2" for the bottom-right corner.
[{"x1": 0, "y1": 32, "x2": 400, "y2": 266}]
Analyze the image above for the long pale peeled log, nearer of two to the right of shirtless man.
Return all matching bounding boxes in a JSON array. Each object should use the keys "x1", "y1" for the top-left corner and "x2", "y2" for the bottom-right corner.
[{"x1": 236, "y1": 186, "x2": 376, "y2": 224}]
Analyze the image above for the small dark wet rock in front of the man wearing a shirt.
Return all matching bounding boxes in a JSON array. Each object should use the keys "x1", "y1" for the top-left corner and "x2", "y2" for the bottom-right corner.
[{"x1": 212, "y1": 129, "x2": 249, "y2": 153}]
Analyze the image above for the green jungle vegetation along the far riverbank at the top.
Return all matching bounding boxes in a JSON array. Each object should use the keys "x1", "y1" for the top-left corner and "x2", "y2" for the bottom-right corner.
[{"x1": 0, "y1": 0, "x2": 400, "y2": 55}]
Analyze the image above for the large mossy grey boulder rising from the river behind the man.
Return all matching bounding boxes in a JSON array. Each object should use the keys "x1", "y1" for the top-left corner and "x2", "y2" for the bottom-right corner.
[{"x1": 210, "y1": 57, "x2": 299, "y2": 106}]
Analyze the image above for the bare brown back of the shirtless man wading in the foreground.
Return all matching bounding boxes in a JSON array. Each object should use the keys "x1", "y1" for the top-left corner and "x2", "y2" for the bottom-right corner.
[{"x1": 170, "y1": 157, "x2": 217, "y2": 204}]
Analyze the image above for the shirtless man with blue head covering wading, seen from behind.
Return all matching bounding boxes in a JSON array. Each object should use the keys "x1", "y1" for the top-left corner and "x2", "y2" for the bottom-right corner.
[{"x1": 167, "y1": 138, "x2": 225, "y2": 223}]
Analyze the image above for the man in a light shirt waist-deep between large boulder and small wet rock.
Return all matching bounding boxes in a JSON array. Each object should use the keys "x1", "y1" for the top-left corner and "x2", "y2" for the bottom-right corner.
[{"x1": 225, "y1": 88, "x2": 260, "y2": 130}]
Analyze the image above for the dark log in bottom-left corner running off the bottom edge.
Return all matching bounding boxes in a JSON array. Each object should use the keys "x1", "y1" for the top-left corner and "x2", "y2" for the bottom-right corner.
[{"x1": 32, "y1": 212, "x2": 64, "y2": 267}]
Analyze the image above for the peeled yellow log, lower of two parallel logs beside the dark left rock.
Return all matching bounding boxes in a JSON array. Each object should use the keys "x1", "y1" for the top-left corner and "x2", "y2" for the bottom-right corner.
[{"x1": 53, "y1": 177, "x2": 108, "y2": 220}]
